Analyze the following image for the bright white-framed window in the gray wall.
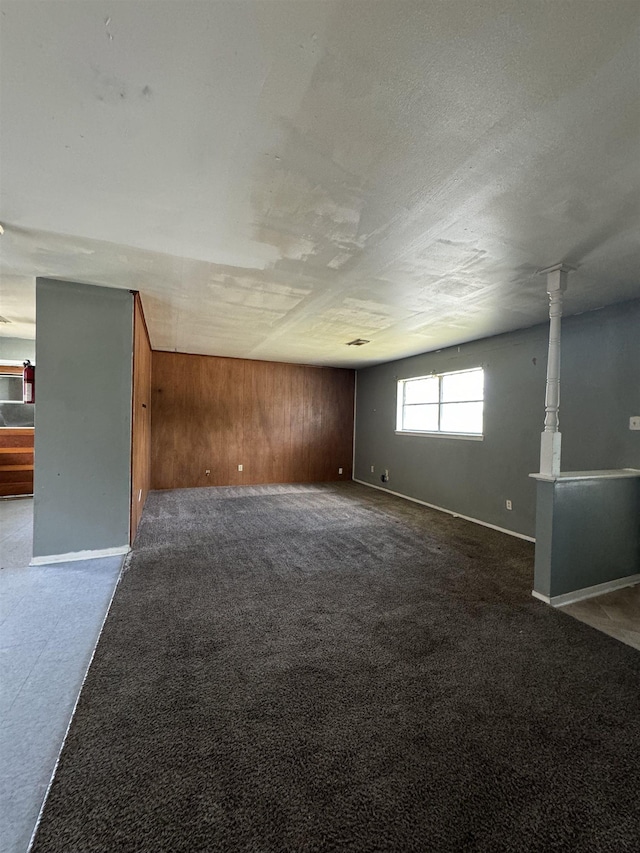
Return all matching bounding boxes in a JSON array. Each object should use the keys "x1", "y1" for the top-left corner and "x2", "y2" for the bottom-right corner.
[{"x1": 396, "y1": 367, "x2": 484, "y2": 437}]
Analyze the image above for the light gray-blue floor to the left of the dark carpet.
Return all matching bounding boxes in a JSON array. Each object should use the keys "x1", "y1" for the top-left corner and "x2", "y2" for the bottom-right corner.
[{"x1": 0, "y1": 498, "x2": 122, "y2": 853}]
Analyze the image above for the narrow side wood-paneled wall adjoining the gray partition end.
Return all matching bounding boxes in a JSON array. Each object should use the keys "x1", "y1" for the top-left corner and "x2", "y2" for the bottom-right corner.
[{"x1": 130, "y1": 293, "x2": 151, "y2": 542}]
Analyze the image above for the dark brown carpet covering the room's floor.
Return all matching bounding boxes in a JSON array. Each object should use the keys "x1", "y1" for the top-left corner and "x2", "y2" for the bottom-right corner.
[{"x1": 33, "y1": 484, "x2": 640, "y2": 853}]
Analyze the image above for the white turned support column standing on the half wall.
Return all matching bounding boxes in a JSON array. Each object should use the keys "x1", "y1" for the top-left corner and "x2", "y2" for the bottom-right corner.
[{"x1": 540, "y1": 264, "x2": 573, "y2": 476}]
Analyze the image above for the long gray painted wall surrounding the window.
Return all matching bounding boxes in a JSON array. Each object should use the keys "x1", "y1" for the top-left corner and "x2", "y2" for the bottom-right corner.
[{"x1": 354, "y1": 300, "x2": 640, "y2": 536}]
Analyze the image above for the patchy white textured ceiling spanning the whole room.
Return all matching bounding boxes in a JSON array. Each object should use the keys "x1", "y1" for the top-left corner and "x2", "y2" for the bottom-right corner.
[{"x1": 0, "y1": 0, "x2": 640, "y2": 366}]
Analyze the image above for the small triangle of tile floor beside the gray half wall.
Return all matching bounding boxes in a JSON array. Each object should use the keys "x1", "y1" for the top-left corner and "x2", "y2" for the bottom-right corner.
[{"x1": 558, "y1": 585, "x2": 640, "y2": 651}]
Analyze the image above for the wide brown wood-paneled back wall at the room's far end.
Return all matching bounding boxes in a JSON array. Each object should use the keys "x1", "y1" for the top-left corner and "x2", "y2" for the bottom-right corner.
[{"x1": 151, "y1": 351, "x2": 355, "y2": 489}]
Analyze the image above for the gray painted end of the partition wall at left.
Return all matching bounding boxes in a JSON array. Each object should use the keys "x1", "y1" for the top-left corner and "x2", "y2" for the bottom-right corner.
[{"x1": 33, "y1": 278, "x2": 133, "y2": 557}]
